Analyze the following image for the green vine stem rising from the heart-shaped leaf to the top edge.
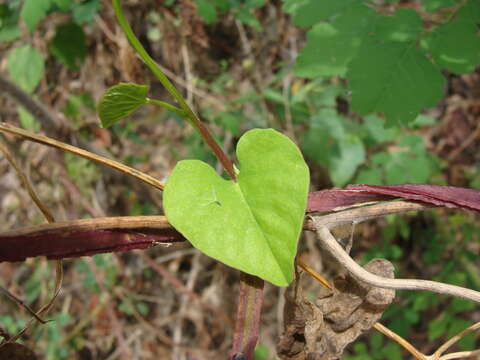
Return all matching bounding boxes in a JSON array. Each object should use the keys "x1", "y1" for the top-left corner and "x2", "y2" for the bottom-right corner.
[{"x1": 112, "y1": 0, "x2": 236, "y2": 181}]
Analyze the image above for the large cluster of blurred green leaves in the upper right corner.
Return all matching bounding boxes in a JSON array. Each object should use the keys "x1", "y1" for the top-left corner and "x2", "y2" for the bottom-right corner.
[{"x1": 284, "y1": 0, "x2": 480, "y2": 126}]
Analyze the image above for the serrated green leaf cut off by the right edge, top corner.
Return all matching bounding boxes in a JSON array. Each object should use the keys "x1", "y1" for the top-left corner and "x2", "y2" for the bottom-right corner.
[{"x1": 422, "y1": 1, "x2": 480, "y2": 74}]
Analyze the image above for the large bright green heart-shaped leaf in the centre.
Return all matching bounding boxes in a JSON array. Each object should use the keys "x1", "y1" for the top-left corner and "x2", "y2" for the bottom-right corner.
[{"x1": 163, "y1": 129, "x2": 309, "y2": 286}]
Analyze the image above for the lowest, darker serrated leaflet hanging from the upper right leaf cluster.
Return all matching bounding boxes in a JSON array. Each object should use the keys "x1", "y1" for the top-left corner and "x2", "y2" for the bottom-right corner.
[{"x1": 347, "y1": 37, "x2": 445, "y2": 126}]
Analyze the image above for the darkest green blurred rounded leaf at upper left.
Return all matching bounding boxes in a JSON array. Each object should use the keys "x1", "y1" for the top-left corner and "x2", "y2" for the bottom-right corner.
[{"x1": 49, "y1": 23, "x2": 87, "y2": 70}]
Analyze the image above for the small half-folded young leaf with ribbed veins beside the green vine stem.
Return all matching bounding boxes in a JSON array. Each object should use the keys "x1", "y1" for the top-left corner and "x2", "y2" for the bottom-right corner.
[{"x1": 98, "y1": 83, "x2": 150, "y2": 128}]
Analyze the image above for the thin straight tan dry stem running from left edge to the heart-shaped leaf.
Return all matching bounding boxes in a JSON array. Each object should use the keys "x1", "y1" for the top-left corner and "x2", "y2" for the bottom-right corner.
[{"x1": 0, "y1": 123, "x2": 164, "y2": 190}]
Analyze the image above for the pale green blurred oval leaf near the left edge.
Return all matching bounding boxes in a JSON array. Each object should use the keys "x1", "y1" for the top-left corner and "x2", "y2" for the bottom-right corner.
[{"x1": 7, "y1": 45, "x2": 45, "y2": 93}]
